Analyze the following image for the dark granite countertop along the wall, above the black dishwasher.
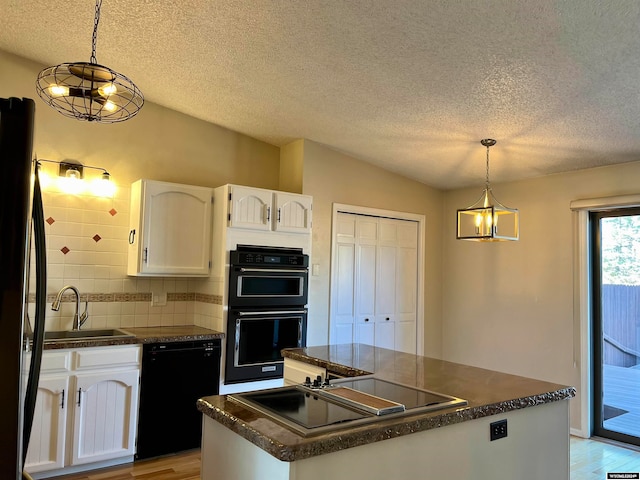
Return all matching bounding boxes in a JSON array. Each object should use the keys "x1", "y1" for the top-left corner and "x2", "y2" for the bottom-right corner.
[{"x1": 44, "y1": 325, "x2": 224, "y2": 350}]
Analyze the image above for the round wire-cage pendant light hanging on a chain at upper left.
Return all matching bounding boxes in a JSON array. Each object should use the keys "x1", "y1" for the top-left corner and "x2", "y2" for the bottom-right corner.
[{"x1": 36, "y1": 0, "x2": 144, "y2": 123}]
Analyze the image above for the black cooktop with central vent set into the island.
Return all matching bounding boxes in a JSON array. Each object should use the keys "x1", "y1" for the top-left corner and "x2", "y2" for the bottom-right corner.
[{"x1": 229, "y1": 377, "x2": 467, "y2": 436}]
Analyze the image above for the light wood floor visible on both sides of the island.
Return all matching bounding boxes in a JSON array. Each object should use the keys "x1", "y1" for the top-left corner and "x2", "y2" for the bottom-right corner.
[{"x1": 46, "y1": 437, "x2": 640, "y2": 480}]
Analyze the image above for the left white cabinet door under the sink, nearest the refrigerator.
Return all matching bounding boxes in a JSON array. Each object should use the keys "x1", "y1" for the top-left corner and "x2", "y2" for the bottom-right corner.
[{"x1": 25, "y1": 375, "x2": 69, "y2": 473}]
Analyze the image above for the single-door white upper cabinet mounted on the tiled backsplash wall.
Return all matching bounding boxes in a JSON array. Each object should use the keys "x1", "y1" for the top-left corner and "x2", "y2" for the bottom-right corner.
[{"x1": 127, "y1": 180, "x2": 213, "y2": 277}]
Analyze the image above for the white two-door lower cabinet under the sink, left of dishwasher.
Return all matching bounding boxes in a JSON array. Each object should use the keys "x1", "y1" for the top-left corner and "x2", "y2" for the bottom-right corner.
[{"x1": 25, "y1": 345, "x2": 140, "y2": 473}]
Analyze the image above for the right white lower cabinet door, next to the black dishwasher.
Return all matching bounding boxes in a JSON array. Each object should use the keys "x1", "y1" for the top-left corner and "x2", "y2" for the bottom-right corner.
[{"x1": 70, "y1": 370, "x2": 139, "y2": 465}]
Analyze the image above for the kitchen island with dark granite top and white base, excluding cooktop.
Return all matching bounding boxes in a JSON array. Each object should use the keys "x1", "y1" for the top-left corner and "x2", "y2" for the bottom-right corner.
[{"x1": 198, "y1": 344, "x2": 575, "y2": 480}]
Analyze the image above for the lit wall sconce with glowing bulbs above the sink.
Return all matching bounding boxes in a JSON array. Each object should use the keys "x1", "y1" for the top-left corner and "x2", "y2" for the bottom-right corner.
[{"x1": 35, "y1": 158, "x2": 116, "y2": 197}]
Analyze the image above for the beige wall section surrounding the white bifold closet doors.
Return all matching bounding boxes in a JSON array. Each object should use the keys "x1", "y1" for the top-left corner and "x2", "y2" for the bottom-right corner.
[{"x1": 303, "y1": 140, "x2": 443, "y2": 357}]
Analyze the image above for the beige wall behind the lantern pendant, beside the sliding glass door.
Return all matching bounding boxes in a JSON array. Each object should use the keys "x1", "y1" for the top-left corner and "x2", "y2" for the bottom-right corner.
[{"x1": 442, "y1": 163, "x2": 640, "y2": 429}]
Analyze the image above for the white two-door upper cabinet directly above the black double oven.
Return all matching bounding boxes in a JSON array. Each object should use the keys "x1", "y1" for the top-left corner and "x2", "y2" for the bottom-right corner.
[{"x1": 227, "y1": 185, "x2": 312, "y2": 233}]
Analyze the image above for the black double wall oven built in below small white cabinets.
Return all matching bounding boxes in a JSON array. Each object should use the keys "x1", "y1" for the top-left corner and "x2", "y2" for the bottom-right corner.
[{"x1": 225, "y1": 245, "x2": 309, "y2": 384}]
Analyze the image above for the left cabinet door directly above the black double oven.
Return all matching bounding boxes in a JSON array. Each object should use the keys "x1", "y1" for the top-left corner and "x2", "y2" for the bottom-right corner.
[{"x1": 228, "y1": 185, "x2": 273, "y2": 230}]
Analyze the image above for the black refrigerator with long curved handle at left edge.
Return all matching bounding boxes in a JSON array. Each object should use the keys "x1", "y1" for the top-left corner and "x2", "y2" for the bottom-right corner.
[{"x1": 0, "y1": 98, "x2": 46, "y2": 480}]
